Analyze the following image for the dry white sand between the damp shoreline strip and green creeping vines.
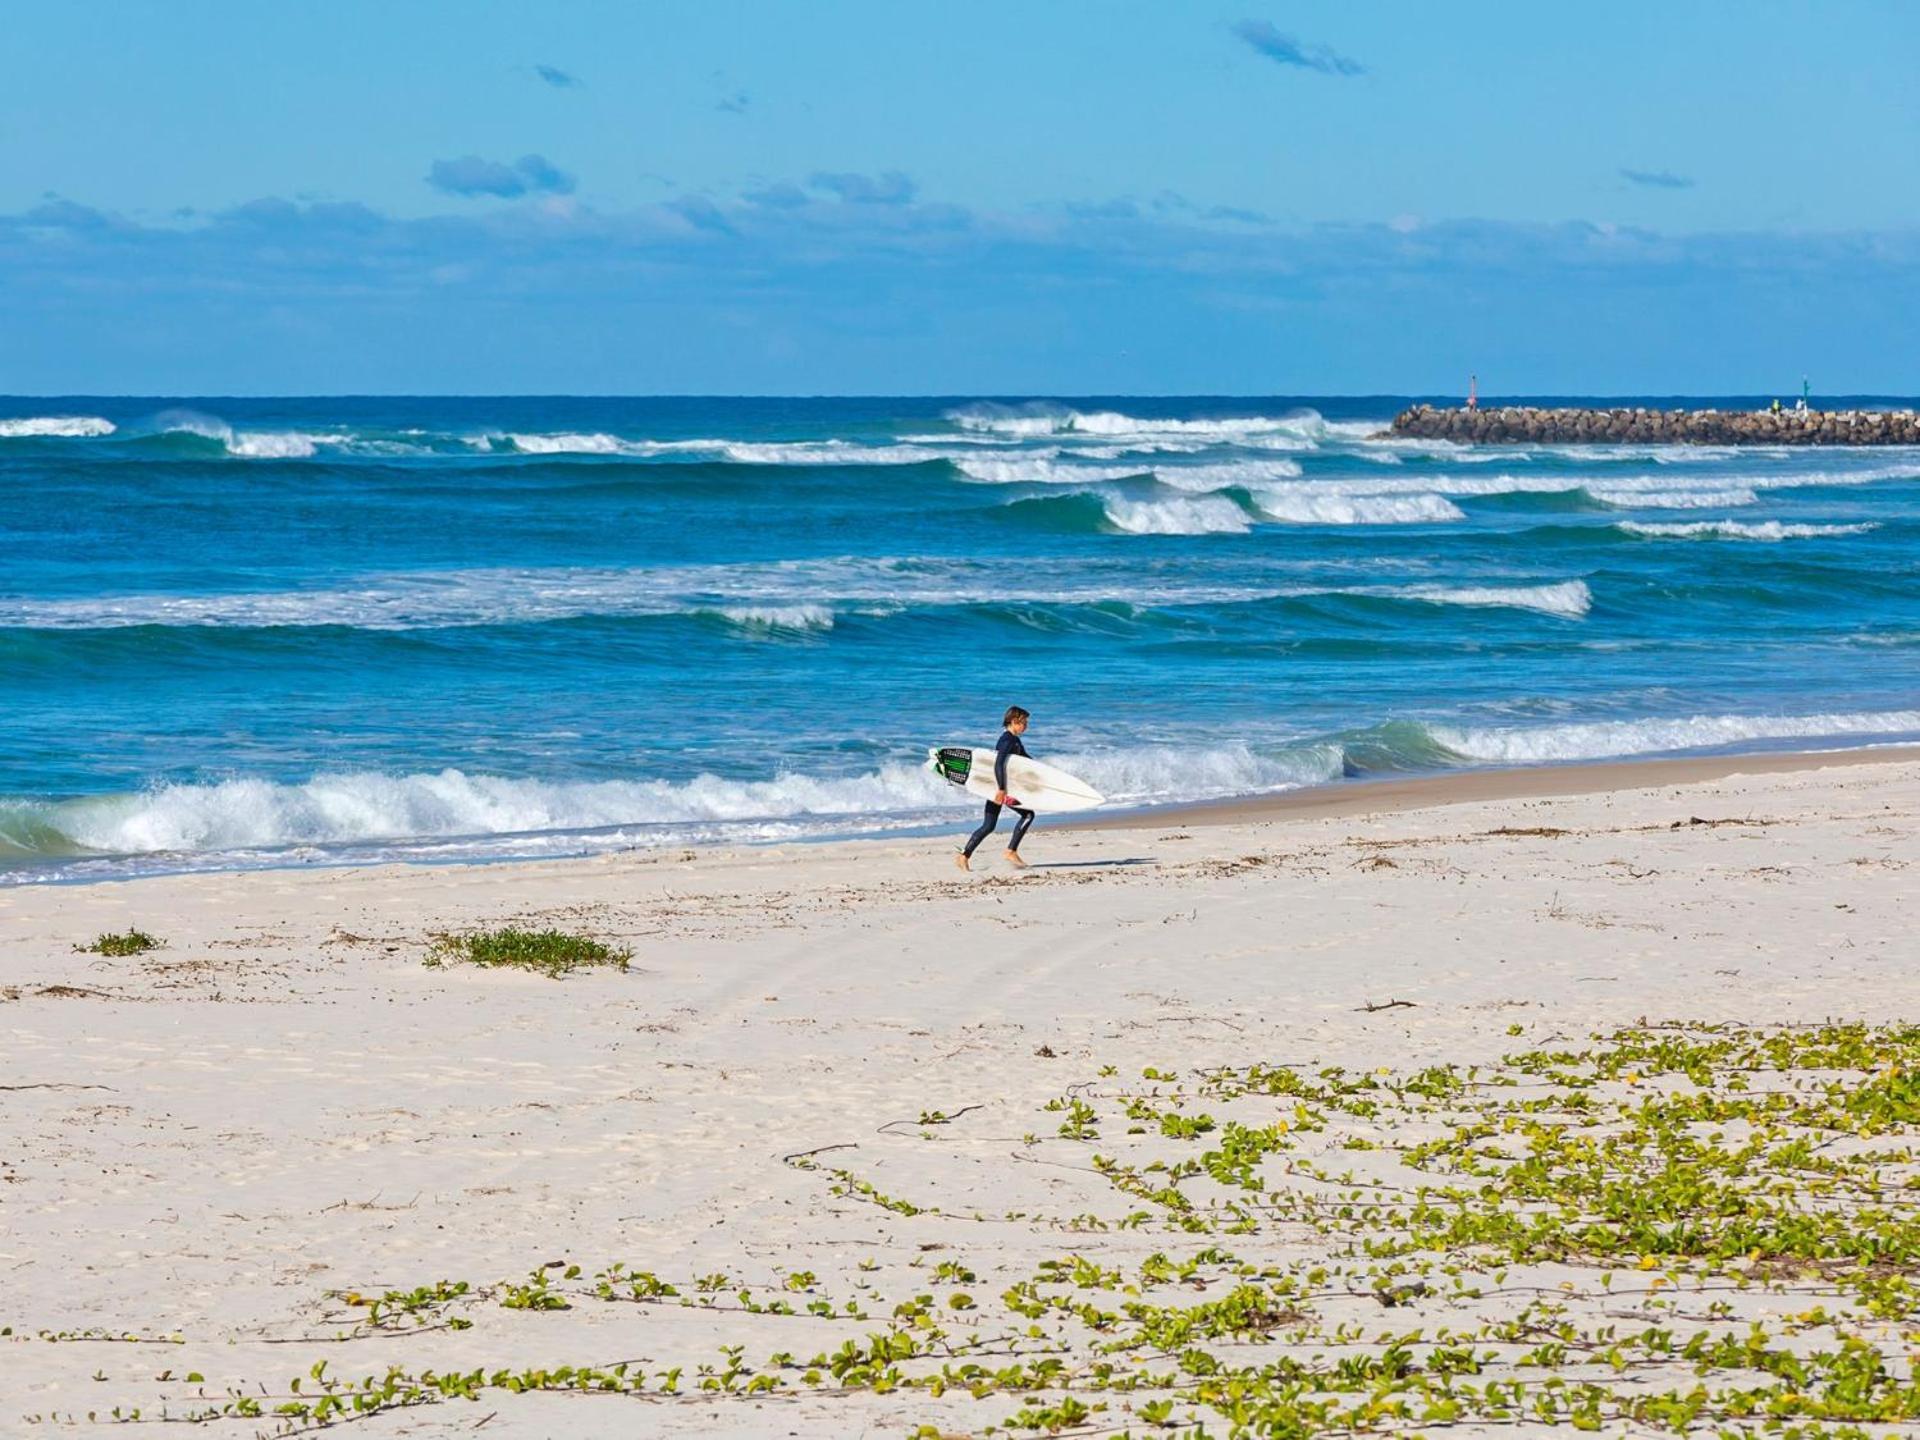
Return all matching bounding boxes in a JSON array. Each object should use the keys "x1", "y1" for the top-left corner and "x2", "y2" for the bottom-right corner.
[{"x1": 0, "y1": 762, "x2": 1920, "y2": 1440}]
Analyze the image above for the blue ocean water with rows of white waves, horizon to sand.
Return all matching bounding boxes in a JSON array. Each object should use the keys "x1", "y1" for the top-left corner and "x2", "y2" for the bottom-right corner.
[{"x1": 0, "y1": 397, "x2": 1920, "y2": 883}]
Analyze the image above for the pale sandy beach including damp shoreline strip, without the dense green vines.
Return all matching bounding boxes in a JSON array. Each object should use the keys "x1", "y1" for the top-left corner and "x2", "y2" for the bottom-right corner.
[{"x1": 0, "y1": 751, "x2": 1920, "y2": 1440}]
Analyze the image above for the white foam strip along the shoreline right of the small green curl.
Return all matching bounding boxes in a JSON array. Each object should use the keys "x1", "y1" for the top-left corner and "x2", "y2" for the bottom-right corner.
[{"x1": 1428, "y1": 710, "x2": 1920, "y2": 764}]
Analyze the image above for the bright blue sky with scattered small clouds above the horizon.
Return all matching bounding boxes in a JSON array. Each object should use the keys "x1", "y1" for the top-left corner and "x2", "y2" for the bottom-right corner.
[{"x1": 0, "y1": 0, "x2": 1920, "y2": 394}]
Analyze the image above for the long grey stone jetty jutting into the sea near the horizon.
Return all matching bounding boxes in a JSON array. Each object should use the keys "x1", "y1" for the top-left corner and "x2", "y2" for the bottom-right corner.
[{"x1": 1392, "y1": 405, "x2": 1920, "y2": 445}]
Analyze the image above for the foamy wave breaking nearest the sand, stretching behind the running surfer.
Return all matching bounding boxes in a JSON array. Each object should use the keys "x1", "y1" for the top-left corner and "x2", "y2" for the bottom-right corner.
[{"x1": 0, "y1": 710, "x2": 1920, "y2": 876}]
